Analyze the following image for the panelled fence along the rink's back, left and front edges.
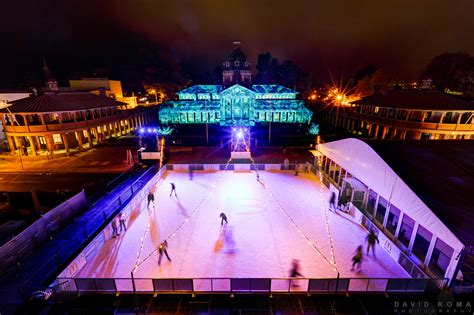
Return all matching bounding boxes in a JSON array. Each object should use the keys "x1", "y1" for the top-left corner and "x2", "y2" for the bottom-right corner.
[{"x1": 50, "y1": 164, "x2": 447, "y2": 294}]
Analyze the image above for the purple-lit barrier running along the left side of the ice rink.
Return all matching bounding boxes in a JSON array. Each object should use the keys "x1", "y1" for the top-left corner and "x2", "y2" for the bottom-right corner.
[{"x1": 53, "y1": 168, "x2": 164, "y2": 285}]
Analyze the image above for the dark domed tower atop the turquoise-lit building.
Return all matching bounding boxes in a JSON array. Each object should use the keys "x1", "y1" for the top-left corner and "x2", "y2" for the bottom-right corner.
[{"x1": 222, "y1": 41, "x2": 252, "y2": 86}]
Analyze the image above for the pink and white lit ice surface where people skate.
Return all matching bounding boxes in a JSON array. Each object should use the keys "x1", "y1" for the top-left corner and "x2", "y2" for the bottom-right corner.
[{"x1": 76, "y1": 171, "x2": 409, "y2": 278}]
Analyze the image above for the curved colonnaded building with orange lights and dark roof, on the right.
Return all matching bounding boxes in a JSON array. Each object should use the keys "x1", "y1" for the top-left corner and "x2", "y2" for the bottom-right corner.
[{"x1": 324, "y1": 90, "x2": 474, "y2": 139}]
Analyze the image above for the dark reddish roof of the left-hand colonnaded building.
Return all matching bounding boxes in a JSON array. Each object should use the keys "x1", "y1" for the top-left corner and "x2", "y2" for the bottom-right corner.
[{"x1": 0, "y1": 93, "x2": 127, "y2": 113}]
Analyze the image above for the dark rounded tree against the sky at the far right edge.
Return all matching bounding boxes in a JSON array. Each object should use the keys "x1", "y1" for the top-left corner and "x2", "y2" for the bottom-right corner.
[{"x1": 423, "y1": 52, "x2": 474, "y2": 96}]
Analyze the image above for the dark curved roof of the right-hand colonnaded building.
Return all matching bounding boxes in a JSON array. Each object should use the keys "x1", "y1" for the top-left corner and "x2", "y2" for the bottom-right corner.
[{"x1": 353, "y1": 90, "x2": 474, "y2": 110}]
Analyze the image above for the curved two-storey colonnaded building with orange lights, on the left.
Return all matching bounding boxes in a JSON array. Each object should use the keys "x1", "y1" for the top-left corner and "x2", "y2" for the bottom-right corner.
[{"x1": 0, "y1": 92, "x2": 149, "y2": 157}]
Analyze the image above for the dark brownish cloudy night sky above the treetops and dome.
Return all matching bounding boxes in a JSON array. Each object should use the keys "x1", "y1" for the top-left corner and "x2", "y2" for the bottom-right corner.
[{"x1": 0, "y1": 0, "x2": 474, "y2": 87}]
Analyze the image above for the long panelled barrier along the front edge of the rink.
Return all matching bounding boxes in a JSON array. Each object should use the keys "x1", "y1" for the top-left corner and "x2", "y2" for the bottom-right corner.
[{"x1": 54, "y1": 278, "x2": 447, "y2": 294}]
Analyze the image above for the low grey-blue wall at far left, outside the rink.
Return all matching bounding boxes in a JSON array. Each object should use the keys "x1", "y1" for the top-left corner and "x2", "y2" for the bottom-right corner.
[{"x1": 0, "y1": 190, "x2": 88, "y2": 275}]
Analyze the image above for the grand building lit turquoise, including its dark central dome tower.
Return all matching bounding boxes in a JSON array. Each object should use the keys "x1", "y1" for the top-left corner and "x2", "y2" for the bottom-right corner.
[{"x1": 159, "y1": 43, "x2": 313, "y2": 126}]
